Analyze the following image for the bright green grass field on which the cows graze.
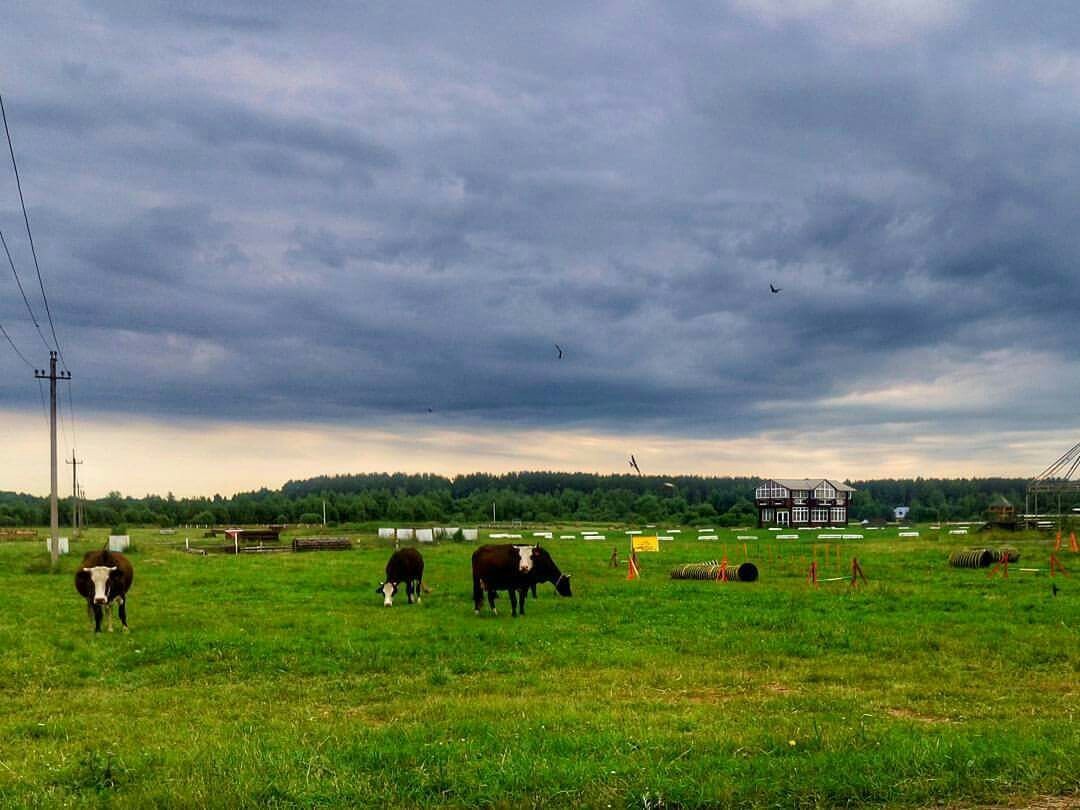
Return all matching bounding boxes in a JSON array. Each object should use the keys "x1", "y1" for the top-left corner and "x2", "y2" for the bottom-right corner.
[{"x1": 0, "y1": 527, "x2": 1080, "y2": 808}]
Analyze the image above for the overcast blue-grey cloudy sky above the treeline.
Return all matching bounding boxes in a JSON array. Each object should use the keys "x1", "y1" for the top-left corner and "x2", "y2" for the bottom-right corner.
[{"x1": 0, "y1": 0, "x2": 1080, "y2": 495}]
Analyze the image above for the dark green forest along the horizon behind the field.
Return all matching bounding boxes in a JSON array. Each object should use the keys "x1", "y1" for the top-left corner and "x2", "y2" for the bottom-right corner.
[{"x1": 0, "y1": 472, "x2": 1045, "y2": 527}]
